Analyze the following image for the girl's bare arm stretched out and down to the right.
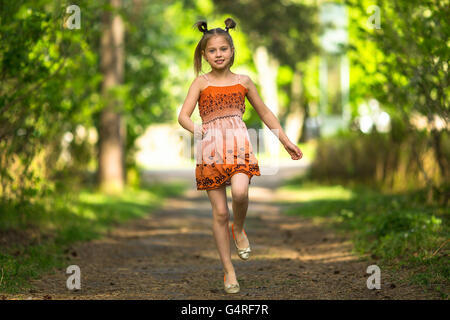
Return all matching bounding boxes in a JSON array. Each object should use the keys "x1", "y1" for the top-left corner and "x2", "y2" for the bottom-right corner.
[{"x1": 243, "y1": 76, "x2": 303, "y2": 160}]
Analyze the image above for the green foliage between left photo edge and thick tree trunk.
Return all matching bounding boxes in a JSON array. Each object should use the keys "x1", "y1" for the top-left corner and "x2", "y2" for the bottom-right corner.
[{"x1": 0, "y1": 1, "x2": 100, "y2": 201}]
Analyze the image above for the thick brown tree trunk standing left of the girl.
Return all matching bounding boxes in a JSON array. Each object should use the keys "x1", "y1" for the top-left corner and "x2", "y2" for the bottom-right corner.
[{"x1": 98, "y1": 0, "x2": 125, "y2": 194}]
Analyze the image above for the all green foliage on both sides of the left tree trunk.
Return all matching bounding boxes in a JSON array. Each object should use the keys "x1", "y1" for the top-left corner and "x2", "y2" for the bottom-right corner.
[{"x1": 0, "y1": 0, "x2": 187, "y2": 208}]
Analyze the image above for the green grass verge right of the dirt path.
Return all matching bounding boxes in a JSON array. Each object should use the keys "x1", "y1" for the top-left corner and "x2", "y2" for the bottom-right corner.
[{"x1": 280, "y1": 178, "x2": 450, "y2": 299}]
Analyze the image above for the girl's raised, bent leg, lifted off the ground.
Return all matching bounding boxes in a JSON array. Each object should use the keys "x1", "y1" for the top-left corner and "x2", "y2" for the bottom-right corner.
[{"x1": 231, "y1": 172, "x2": 250, "y2": 249}]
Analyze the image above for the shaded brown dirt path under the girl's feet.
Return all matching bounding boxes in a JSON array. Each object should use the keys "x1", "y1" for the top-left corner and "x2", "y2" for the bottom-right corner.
[{"x1": 10, "y1": 164, "x2": 439, "y2": 300}]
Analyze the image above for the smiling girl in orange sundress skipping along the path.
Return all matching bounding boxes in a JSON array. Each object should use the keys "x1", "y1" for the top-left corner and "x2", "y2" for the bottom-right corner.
[{"x1": 178, "y1": 18, "x2": 303, "y2": 293}]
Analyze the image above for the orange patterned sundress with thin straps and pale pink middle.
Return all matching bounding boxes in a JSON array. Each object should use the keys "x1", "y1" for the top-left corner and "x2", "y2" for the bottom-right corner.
[{"x1": 195, "y1": 75, "x2": 261, "y2": 190}]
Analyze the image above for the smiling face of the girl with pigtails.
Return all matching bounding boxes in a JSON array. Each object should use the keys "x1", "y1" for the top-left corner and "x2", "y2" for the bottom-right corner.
[{"x1": 203, "y1": 36, "x2": 234, "y2": 69}]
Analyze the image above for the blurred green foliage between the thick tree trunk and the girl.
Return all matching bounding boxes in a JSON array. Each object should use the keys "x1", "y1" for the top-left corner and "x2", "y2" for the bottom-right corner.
[{"x1": 118, "y1": 1, "x2": 189, "y2": 168}]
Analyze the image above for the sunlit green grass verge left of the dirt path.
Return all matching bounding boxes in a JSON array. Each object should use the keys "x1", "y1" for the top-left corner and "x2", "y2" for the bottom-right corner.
[{"x1": 0, "y1": 179, "x2": 187, "y2": 294}]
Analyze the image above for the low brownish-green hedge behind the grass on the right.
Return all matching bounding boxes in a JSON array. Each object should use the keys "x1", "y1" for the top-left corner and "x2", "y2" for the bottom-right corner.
[{"x1": 309, "y1": 127, "x2": 450, "y2": 195}]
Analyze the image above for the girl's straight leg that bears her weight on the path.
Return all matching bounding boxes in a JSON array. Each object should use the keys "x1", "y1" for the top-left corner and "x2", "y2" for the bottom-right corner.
[{"x1": 207, "y1": 186, "x2": 237, "y2": 284}]
